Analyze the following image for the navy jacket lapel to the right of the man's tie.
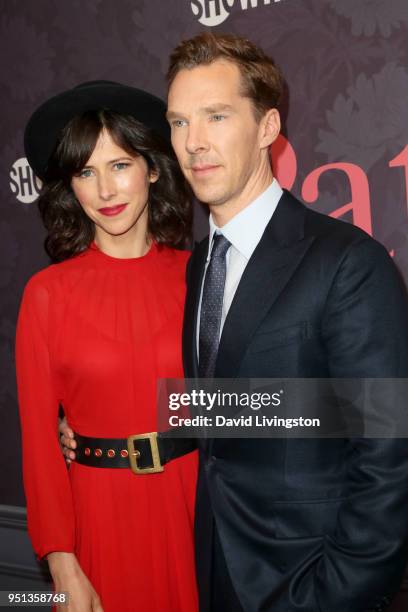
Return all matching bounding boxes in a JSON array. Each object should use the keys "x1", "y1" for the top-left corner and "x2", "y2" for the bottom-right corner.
[{"x1": 215, "y1": 192, "x2": 314, "y2": 378}]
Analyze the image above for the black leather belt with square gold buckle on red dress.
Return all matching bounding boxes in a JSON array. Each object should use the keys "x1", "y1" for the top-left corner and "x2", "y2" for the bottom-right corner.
[{"x1": 75, "y1": 431, "x2": 197, "y2": 474}]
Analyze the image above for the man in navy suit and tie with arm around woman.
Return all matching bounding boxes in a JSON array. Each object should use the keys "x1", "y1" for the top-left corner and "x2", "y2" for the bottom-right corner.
[{"x1": 61, "y1": 33, "x2": 408, "y2": 612}]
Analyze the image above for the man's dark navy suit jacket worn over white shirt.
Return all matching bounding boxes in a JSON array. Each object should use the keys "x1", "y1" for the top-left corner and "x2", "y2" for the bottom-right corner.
[{"x1": 183, "y1": 192, "x2": 408, "y2": 612}]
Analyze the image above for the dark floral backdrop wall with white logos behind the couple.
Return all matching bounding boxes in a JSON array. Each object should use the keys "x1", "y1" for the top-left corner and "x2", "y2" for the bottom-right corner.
[{"x1": 0, "y1": 0, "x2": 408, "y2": 592}]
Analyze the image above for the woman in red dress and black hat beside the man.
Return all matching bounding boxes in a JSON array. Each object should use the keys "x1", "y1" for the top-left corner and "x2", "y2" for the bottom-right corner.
[{"x1": 16, "y1": 81, "x2": 197, "y2": 612}]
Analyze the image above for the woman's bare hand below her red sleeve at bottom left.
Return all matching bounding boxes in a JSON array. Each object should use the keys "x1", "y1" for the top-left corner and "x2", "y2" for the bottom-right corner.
[{"x1": 47, "y1": 552, "x2": 103, "y2": 612}]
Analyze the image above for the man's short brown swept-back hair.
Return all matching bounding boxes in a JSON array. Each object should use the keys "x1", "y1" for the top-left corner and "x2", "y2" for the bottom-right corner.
[{"x1": 167, "y1": 32, "x2": 284, "y2": 121}]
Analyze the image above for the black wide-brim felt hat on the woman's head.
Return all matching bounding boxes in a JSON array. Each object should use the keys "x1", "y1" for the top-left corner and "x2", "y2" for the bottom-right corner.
[{"x1": 24, "y1": 81, "x2": 170, "y2": 180}]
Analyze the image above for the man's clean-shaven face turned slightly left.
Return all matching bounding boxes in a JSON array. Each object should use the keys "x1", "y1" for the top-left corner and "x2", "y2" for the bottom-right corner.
[{"x1": 168, "y1": 60, "x2": 279, "y2": 216}]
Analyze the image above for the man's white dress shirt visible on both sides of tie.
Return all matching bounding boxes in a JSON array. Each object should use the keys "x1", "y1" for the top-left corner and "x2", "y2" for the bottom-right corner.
[{"x1": 197, "y1": 179, "x2": 283, "y2": 355}]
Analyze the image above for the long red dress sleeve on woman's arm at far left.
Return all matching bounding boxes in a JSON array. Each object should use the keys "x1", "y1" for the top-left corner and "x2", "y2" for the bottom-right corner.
[{"x1": 16, "y1": 277, "x2": 75, "y2": 558}]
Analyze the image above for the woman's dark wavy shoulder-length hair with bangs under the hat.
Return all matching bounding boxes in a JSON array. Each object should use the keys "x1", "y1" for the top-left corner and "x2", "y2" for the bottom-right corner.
[{"x1": 38, "y1": 110, "x2": 192, "y2": 262}]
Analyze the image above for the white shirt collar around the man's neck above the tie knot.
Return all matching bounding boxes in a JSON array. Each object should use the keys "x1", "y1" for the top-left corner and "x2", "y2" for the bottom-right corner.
[{"x1": 207, "y1": 179, "x2": 283, "y2": 261}]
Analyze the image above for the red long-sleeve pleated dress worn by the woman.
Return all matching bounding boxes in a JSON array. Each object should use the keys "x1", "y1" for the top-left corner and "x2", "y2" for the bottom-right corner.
[{"x1": 16, "y1": 244, "x2": 197, "y2": 612}]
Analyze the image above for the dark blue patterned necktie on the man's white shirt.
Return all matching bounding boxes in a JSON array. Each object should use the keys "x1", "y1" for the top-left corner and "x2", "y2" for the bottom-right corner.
[{"x1": 198, "y1": 234, "x2": 231, "y2": 378}]
